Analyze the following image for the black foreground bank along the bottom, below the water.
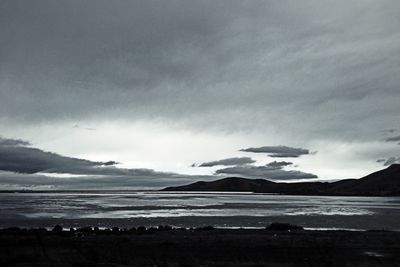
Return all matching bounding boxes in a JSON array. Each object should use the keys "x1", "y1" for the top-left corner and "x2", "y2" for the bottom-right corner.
[{"x1": 0, "y1": 227, "x2": 400, "y2": 267}]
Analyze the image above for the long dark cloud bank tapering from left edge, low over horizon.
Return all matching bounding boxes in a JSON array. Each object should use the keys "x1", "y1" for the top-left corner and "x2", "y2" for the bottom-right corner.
[{"x1": 0, "y1": 138, "x2": 222, "y2": 189}]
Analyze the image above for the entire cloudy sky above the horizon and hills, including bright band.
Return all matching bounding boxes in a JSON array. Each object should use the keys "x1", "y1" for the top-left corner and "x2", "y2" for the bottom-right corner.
[{"x1": 0, "y1": 0, "x2": 400, "y2": 189}]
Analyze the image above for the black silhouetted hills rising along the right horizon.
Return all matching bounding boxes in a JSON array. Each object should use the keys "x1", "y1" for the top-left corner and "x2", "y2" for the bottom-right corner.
[{"x1": 163, "y1": 164, "x2": 400, "y2": 196}]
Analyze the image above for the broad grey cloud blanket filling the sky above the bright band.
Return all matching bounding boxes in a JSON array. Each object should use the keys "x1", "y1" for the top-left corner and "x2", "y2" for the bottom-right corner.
[{"x1": 0, "y1": 0, "x2": 400, "y2": 142}]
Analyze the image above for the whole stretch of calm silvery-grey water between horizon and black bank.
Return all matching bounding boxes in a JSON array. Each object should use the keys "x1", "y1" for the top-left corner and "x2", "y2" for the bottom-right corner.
[{"x1": 0, "y1": 191, "x2": 400, "y2": 230}]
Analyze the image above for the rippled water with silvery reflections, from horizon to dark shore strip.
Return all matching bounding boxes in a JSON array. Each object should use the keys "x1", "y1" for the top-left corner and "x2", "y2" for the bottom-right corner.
[{"x1": 0, "y1": 192, "x2": 400, "y2": 219}]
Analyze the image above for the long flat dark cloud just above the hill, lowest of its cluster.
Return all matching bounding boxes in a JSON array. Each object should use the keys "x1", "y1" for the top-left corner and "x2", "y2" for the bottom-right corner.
[{"x1": 216, "y1": 166, "x2": 318, "y2": 180}]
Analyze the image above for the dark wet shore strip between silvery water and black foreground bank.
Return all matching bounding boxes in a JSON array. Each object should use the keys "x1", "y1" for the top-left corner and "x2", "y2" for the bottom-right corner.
[{"x1": 0, "y1": 214, "x2": 400, "y2": 231}]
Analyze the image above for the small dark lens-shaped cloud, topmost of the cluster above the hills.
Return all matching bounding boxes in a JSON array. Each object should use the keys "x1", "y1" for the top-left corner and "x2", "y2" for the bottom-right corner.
[{"x1": 240, "y1": 146, "x2": 310, "y2": 158}]
